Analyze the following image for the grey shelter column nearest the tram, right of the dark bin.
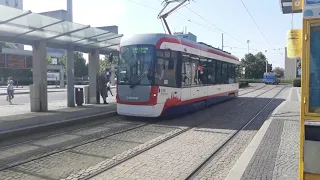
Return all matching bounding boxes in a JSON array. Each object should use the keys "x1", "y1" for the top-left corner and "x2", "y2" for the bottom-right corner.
[{"x1": 88, "y1": 49, "x2": 100, "y2": 104}]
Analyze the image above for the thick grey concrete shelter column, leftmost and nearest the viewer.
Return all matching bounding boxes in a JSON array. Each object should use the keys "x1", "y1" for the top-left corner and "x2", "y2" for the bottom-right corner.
[{"x1": 30, "y1": 41, "x2": 48, "y2": 112}]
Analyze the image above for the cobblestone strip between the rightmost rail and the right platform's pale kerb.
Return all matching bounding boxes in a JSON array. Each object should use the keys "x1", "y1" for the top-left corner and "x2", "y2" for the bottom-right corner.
[{"x1": 195, "y1": 88, "x2": 289, "y2": 180}]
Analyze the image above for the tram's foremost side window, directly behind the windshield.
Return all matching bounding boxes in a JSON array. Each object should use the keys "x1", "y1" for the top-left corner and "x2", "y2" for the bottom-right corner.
[{"x1": 155, "y1": 51, "x2": 177, "y2": 87}]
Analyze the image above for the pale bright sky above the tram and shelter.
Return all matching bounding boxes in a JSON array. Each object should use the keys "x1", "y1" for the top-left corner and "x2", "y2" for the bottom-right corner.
[{"x1": 23, "y1": 0, "x2": 302, "y2": 67}]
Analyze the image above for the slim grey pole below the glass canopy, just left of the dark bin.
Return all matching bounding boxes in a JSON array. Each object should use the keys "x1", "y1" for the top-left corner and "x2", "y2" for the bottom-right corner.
[{"x1": 67, "y1": 49, "x2": 75, "y2": 107}]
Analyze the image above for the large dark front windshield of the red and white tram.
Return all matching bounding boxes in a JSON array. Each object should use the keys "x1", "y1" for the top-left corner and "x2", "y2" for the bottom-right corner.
[{"x1": 117, "y1": 45, "x2": 154, "y2": 87}]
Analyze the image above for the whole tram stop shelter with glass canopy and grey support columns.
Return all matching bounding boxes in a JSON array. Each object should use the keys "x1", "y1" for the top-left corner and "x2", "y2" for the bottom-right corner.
[{"x1": 0, "y1": 5, "x2": 122, "y2": 112}]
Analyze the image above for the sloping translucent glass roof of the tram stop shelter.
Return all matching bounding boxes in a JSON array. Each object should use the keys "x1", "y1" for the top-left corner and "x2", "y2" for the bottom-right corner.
[{"x1": 0, "y1": 5, "x2": 123, "y2": 54}]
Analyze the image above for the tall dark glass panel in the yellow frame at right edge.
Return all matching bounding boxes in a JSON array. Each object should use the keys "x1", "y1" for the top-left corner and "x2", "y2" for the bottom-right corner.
[{"x1": 309, "y1": 24, "x2": 320, "y2": 113}]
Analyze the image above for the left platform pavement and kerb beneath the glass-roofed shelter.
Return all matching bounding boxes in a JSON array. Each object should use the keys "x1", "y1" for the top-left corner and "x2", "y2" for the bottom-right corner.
[{"x1": 0, "y1": 96, "x2": 117, "y2": 140}]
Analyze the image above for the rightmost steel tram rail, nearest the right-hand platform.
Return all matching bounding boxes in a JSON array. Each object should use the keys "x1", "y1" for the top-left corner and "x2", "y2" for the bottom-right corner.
[{"x1": 186, "y1": 86, "x2": 286, "y2": 180}]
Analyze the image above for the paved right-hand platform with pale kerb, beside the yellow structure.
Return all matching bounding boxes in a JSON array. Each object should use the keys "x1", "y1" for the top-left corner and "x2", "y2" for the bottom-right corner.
[{"x1": 225, "y1": 88, "x2": 300, "y2": 180}]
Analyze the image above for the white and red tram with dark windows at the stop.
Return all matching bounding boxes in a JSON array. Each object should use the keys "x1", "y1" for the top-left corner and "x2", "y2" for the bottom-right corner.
[{"x1": 116, "y1": 34, "x2": 240, "y2": 117}]
